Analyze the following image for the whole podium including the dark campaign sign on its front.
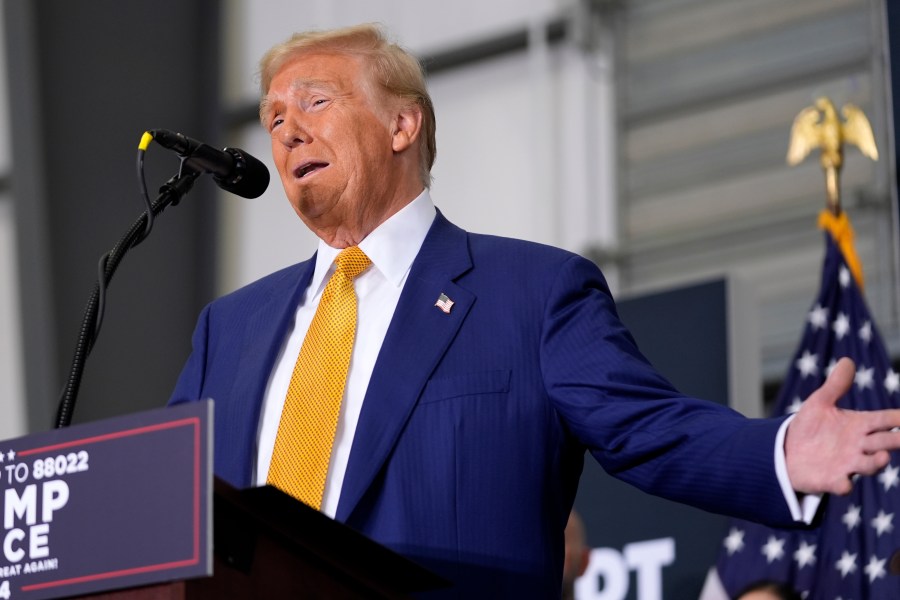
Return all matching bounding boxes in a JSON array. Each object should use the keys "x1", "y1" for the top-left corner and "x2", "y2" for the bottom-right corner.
[{"x1": 0, "y1": 400, "x2": 448, "y2": 600}]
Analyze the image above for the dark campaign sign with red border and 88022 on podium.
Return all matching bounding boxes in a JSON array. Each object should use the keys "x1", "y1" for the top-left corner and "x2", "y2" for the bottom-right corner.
[{"x1": 0, "y1": 401, "x2": 212, "y2": 600}]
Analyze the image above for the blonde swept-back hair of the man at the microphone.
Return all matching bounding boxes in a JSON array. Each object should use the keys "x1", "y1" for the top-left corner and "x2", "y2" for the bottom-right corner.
[{"x1": 259, "y1": 24, "x2": 437, "y2": 187}]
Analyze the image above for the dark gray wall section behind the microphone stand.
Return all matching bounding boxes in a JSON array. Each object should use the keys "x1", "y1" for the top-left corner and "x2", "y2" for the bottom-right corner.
[{"x1": 3, "y1": 0, "x2": 224, "y2": 431}]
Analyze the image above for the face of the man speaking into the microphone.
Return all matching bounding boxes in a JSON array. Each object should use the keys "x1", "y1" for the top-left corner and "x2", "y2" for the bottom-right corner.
[{"x1": 262, "y1": 54, "x2": 421, "y2": 247}]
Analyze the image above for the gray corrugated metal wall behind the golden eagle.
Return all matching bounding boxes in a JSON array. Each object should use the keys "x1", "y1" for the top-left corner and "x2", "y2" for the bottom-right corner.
[{"x1": 617, "y1": 0, "x2": 898, "y2": 378}]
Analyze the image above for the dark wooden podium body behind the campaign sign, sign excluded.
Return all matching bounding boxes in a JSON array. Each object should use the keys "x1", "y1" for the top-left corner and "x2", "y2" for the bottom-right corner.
[{"x1": 77, "y1": 479, "x2": 449, "y2": 600}]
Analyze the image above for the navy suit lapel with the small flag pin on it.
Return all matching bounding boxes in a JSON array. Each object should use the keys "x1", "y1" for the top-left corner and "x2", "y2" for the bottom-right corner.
[{"x1": 335, "y1": 212, "x2": 475, "y2": 521}]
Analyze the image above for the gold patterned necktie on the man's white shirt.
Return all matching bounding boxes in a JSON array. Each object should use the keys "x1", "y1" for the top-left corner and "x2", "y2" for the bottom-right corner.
[{"x1": 267, "y1": 246, "x2": 371, "y2": 509}]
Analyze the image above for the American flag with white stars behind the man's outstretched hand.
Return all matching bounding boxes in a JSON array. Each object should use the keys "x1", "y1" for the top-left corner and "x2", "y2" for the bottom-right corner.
[{"x1": 716, "y1": 226, "x2": 900, "y2": 600}]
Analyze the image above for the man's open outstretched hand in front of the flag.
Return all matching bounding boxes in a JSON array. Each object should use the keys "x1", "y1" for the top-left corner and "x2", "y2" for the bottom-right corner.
[{"x1": 784, "y1": 358, "x2": 900, "y2": 495}]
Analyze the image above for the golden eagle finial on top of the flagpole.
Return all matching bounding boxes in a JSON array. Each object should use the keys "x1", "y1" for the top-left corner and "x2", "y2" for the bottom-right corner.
[{"x1": 787, "y1": 96, "x2": 878, "y2": 215}]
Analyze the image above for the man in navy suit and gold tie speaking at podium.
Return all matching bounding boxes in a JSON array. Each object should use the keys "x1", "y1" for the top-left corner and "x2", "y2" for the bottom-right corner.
[{"x1": 172, "y1": 26, "x2": 900, "y2": 598}]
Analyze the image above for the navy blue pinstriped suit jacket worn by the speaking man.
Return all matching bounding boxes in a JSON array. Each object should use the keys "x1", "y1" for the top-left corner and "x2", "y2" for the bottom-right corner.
[{"x1": 172, "y1": 214, "x2": 790, "y2": 598}]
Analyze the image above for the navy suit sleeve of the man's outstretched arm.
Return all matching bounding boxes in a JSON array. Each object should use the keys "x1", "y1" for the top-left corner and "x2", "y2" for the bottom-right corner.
[{"x1": 541, "y1": 257, "x2": 793, "y2": 525}]
